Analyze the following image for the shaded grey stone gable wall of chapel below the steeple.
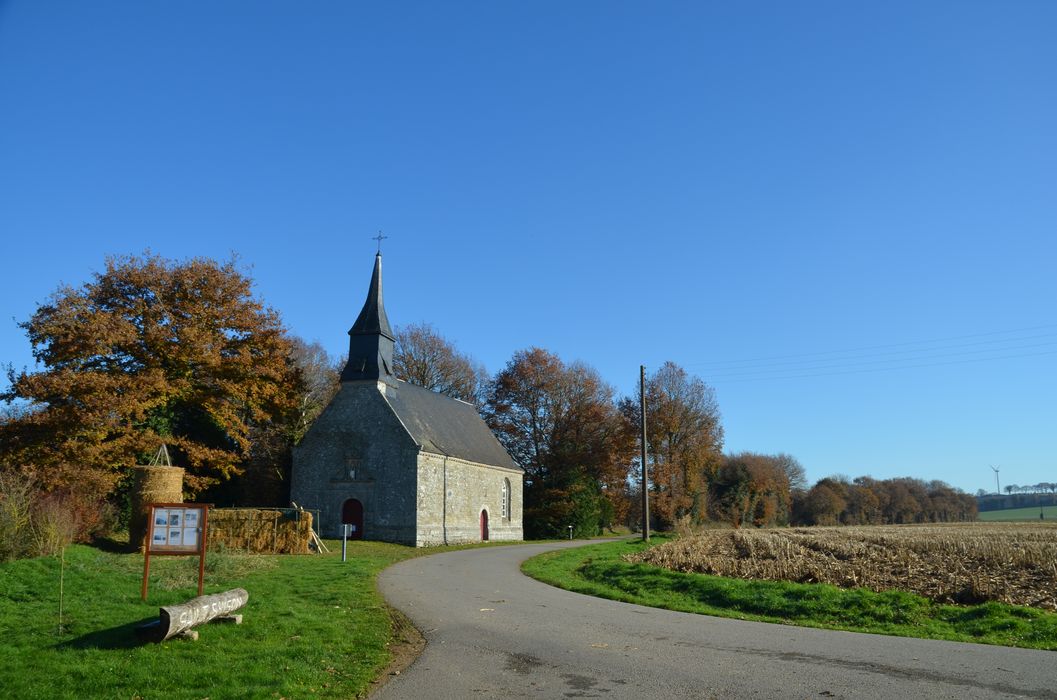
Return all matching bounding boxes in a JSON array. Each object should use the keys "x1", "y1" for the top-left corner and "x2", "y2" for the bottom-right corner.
[{"x1": 291, "y1": 381, "x2": 419, "y2": 545}]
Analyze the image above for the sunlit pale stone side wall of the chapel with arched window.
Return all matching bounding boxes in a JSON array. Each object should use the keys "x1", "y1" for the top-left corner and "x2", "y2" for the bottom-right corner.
[{"x1": 415, "y1": 452, "x2": 524, "y2": 547}]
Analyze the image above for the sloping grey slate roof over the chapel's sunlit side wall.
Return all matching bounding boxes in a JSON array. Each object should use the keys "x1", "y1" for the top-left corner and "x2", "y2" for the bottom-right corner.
[{"x1": 385, "y1": 382, "x2": 521, "y2": 471}]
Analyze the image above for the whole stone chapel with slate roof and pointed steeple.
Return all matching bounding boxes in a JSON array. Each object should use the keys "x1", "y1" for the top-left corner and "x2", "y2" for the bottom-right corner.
[{"x1": 291, "y1": 253, "x2": 524, "y2": 547}]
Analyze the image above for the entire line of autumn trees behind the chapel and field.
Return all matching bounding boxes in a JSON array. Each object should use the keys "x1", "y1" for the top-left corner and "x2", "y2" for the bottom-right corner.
[{"x1": 0, "y1": 254, "x2": 975, "y2": 549}]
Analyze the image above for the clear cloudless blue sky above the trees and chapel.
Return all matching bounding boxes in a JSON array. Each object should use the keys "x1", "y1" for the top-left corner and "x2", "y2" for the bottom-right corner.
[{"x1": 0, "y1": 0, "x2": 1057, "y2": 492}]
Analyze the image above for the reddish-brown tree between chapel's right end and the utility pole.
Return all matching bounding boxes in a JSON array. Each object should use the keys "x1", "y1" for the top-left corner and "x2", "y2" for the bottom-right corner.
[{"x1": 484, "y1": 348, "x2": 630, "y2": 537}]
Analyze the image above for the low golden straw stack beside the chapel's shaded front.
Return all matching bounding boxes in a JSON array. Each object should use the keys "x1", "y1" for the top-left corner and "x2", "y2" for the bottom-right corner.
[{"x1": 209, "y1": 509, "x2": 312, "y2": 554}]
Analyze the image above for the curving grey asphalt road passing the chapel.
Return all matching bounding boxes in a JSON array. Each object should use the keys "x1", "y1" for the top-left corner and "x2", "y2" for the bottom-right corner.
[{"x1": 374, "y1": 542, "x2": 1057, "y2": 700}]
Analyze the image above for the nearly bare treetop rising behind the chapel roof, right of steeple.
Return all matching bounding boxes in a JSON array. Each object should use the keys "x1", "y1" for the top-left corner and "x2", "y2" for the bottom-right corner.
[{"x1": 393, "y1": 324, "x2": 487, "y2": 404}]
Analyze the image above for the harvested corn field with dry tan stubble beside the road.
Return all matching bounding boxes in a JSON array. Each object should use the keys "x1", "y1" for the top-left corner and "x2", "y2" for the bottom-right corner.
[{"x1": 626, "y1": 522, "x2": 1057, "y2": 610}]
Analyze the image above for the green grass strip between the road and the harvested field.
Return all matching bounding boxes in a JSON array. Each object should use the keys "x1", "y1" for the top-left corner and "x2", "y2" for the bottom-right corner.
[{"x1": 522, "y1": 538, "x2": 1057, "y2": 650}]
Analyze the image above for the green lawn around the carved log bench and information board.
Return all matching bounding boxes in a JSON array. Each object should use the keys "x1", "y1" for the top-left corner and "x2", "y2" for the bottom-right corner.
[{"x1": 0, "y1": 542, "x2": 423, "y2": 700}]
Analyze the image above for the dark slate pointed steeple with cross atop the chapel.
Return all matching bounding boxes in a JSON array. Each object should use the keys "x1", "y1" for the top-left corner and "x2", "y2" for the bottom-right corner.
[{"x1": 341, "y1": 253, "x2": 395, "y2": 382}]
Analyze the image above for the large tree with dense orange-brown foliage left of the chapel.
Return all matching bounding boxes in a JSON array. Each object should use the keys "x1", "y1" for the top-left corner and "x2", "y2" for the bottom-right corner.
[{"x1": 0, "y1": 253, "x2": 301, "y2": 492}]
